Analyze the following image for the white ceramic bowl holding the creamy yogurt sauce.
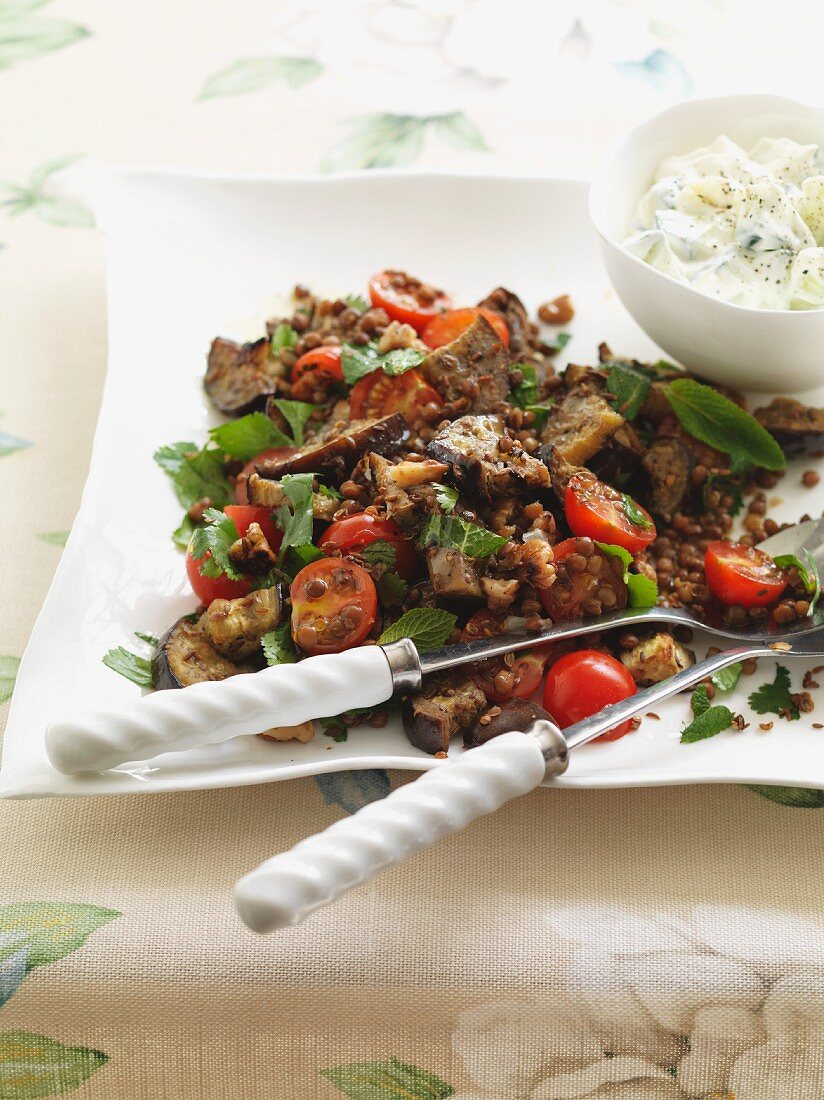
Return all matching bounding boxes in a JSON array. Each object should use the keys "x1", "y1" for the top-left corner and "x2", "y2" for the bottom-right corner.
[{"x1": 590, "y1": 96, "x2": 824, "y2": 392}]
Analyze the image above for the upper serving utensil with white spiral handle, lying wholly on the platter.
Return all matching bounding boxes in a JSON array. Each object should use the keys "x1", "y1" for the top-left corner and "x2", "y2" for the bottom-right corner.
[{"x1": 45, "y1": 519, "x2": 824, "y2": 776}]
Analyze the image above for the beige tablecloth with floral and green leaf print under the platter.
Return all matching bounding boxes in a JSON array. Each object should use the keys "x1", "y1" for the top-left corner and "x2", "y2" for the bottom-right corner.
[{"x1": 0, "y1": 0, "x2": 824, "y2": 1100}]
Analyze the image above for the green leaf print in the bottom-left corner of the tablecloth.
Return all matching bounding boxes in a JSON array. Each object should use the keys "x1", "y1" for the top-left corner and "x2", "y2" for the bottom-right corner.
[{"x1": 0, "y1": 1031, "x2": 109, "y2": 1100}]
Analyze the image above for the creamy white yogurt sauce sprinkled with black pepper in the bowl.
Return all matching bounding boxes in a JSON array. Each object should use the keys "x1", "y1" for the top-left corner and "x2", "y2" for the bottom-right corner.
[{"x1": 624, "y1": 135, "x2": 824, "y2": 309}]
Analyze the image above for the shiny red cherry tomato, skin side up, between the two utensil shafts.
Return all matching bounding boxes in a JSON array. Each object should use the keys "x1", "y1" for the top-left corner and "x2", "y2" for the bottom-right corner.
[{"x1": 543, "y1": 649, "x2": 636, "y2": 741}]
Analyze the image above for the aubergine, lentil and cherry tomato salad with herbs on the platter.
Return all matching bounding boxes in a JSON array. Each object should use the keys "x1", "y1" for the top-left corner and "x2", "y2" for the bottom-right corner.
[{"x1": 105, "y1": 270, "x2": 824, "y2": 755}]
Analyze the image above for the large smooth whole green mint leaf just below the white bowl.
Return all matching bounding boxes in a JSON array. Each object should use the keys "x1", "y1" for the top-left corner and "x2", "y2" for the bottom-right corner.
[{"x1": 663, "y1": 378, "x2": 785, "y2": 470}]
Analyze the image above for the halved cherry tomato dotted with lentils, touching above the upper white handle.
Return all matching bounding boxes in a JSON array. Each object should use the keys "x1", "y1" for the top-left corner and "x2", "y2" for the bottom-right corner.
[{"x1": 289, "y1": 558, "x2": 377, "y2": 656}]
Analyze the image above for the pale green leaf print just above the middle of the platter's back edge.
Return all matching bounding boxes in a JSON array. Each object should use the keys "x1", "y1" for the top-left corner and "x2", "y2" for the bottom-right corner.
[{"x1": 320, "y1": 111, "x2": 490, "y2": 172}]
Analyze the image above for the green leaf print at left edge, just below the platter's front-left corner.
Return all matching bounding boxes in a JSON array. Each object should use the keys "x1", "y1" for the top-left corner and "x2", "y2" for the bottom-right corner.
[{"x1": 0, "y1": 901, "x2": 120, "y2": 972}]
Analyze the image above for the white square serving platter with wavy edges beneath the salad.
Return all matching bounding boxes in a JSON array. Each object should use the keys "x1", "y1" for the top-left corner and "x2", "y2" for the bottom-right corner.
[{"x1": 0, "y1": 169, "x2": 824, "y2": 798}]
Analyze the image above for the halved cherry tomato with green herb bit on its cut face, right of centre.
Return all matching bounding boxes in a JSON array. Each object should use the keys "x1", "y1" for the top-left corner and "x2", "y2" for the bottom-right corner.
[{"x1": 563, "y1": 473, "x2": 657, "y2": 553}]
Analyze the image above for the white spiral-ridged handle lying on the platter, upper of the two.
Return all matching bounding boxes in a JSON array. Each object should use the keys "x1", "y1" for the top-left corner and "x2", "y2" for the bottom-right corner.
[{"x1": 46, "y1": 646, "x2": 393, "y2": 776}]
